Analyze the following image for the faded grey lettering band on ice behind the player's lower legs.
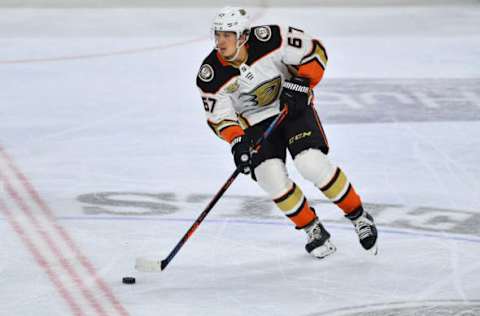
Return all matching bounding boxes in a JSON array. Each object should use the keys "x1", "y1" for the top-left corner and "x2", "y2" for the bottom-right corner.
[{"x1": 77, "y1": 192, "x2": 480, "y2": 242}]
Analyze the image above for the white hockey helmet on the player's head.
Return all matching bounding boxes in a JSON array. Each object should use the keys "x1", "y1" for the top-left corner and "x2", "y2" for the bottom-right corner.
[{"x1": 212, "y1": 7, "x2": 250, "y2": 40}]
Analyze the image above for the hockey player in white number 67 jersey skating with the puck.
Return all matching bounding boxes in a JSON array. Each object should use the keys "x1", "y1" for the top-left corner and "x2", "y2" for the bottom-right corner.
[{"x1": 197, "y1": 7, "x2": 377, "y2": 258}]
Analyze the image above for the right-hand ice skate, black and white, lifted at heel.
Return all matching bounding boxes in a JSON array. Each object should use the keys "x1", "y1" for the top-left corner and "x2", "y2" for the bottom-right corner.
[{"x1": 345, "y1": 207, "x2": 378, "y2": 255}]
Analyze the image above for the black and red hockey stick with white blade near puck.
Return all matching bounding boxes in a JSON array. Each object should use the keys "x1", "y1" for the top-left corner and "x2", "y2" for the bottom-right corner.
[{"x1": 135, "y1": 107, "x2": 288, "y2": 272}]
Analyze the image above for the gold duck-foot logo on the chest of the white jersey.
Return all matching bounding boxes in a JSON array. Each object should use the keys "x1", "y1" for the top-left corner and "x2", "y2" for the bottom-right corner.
[{"x1": 240, "y1": 76, "x2": 282, "y2": 106}]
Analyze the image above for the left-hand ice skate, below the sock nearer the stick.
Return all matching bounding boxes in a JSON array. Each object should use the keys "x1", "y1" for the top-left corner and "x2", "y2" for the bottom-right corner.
[{"x1": 305, "y1": 219, "x2": 337, "y2": 259}]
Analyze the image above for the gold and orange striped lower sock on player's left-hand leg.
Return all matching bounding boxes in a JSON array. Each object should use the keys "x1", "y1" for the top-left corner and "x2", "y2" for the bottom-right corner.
[{"x1": 273, "y1": 183, "x2": 317, "y2": 229}]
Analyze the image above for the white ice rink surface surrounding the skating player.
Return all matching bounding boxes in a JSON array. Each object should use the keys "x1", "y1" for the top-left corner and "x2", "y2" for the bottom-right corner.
[{"x1": 0, "y1": 5, "x2": 480, "y2": 316}]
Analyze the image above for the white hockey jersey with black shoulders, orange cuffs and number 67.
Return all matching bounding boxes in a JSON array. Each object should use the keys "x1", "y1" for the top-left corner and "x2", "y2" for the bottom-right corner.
[{"x1": 197, "y1": 25, "x2": 327, "y2": 142}]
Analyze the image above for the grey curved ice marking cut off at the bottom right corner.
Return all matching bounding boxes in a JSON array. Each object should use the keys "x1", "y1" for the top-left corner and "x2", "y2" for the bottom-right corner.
[{"x1": 305, "y1": 300, "x2": 480, "y2": 316}]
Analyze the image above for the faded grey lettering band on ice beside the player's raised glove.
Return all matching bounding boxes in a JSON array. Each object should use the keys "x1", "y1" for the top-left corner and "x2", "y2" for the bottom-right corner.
[{"x1": 315, "y1": 78, "x2": 480, "y2": 124}]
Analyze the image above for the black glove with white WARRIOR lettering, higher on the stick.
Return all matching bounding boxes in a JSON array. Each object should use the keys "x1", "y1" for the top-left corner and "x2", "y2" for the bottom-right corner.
[{"x1": 280, "y1": 77, "x2": 310, "y2": 118}]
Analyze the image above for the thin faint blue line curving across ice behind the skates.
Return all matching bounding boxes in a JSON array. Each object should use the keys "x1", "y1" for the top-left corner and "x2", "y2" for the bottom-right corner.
[{"x1": 0, "y1": 216, "x2": 480, "y2": 244}]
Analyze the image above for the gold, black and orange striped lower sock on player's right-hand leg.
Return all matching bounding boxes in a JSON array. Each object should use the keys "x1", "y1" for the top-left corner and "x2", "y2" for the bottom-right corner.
[{"x1": 320, "y1": 168, "x2": 362, "y2": 214}]
